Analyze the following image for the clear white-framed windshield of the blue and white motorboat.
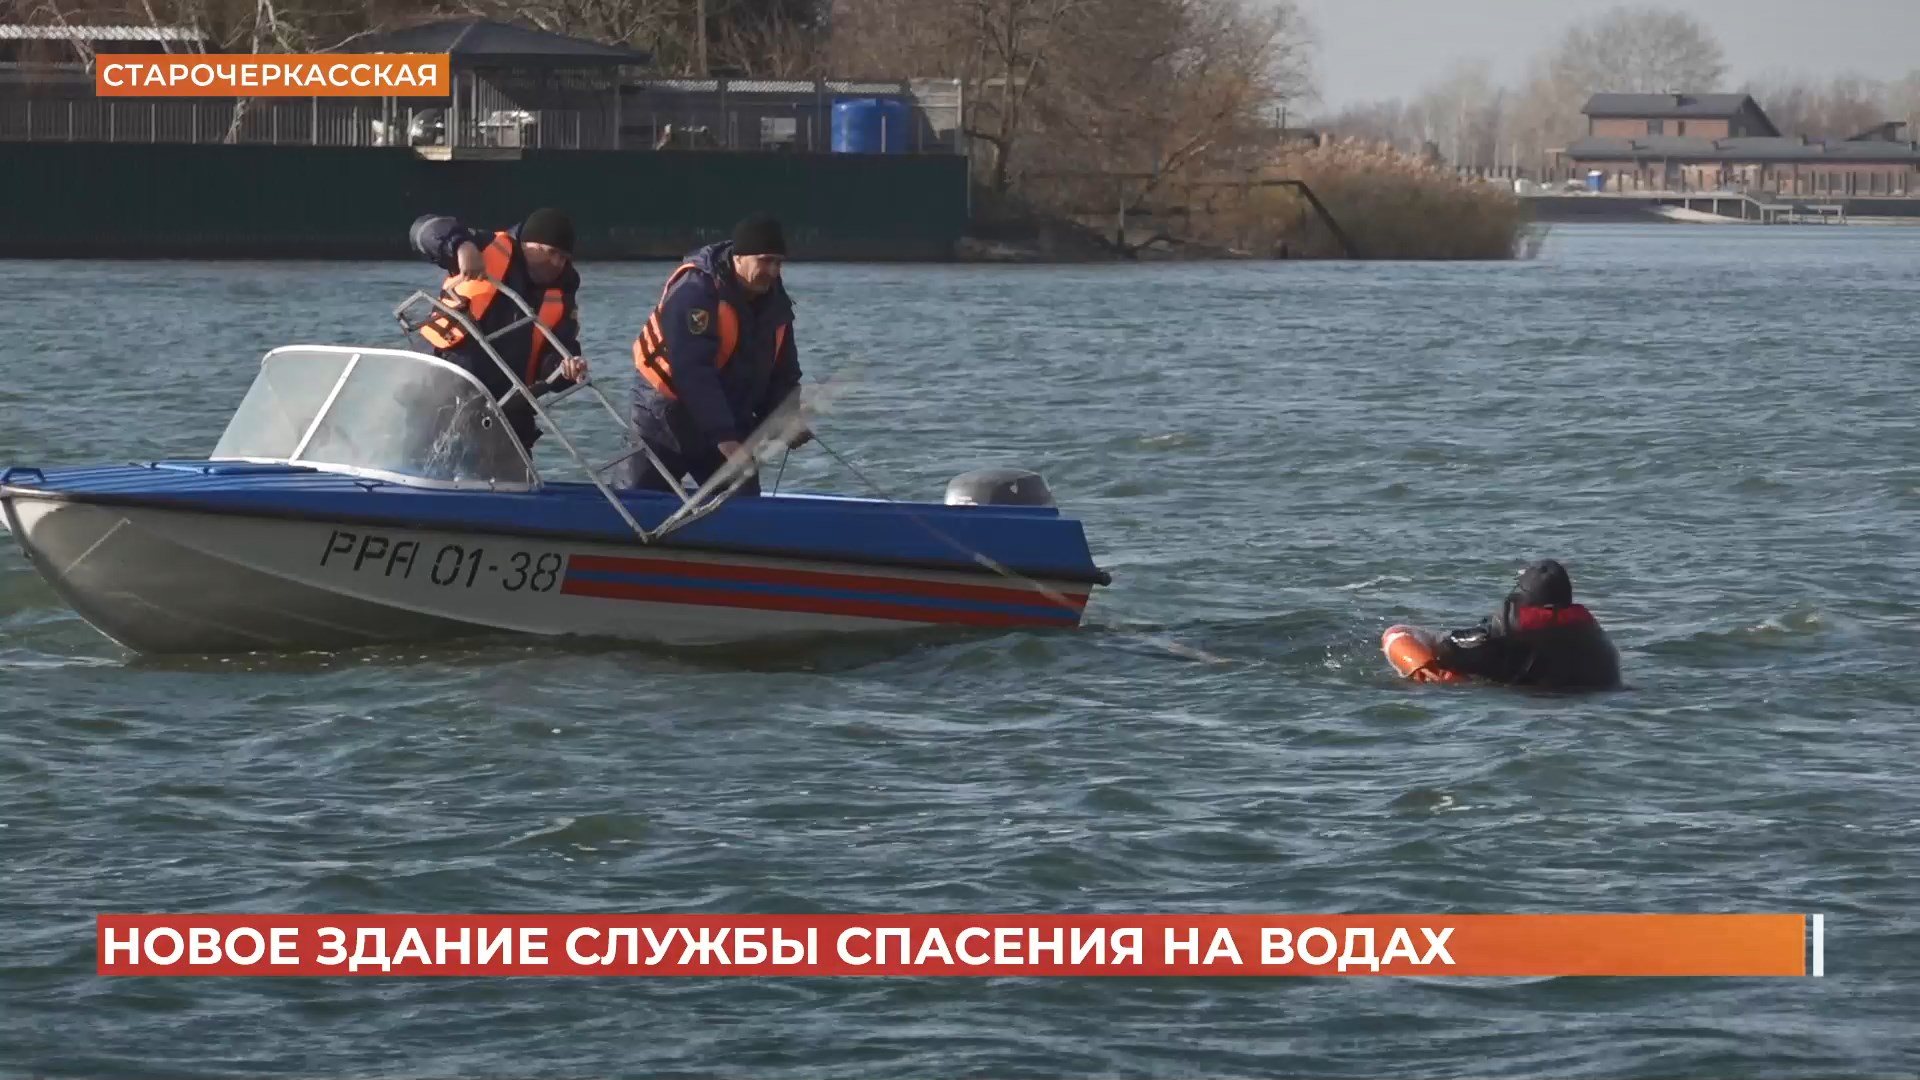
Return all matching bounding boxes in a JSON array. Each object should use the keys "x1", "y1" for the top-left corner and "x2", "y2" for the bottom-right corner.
[{"x1": 213, "y1": 346, "x2": 538, "y2": 490}]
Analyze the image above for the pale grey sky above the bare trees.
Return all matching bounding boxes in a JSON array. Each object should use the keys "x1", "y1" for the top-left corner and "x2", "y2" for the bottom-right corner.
[{"x1": 1296, "y1": 0, "x2": 1920, "y2": 110}]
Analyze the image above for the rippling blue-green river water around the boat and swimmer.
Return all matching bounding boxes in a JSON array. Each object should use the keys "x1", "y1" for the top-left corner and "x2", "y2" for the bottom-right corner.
[{"x1": 0, "y1": 227, "x2": 1920, "y2": 1078}]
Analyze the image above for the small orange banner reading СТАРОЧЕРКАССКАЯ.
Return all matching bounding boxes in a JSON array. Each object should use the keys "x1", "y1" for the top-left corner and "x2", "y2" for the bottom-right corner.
[{"x1": 94, "y1": 52, "x2": 453, "y2": 98}]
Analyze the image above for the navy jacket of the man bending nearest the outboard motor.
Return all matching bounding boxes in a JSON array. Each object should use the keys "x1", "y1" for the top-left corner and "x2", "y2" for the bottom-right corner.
[{"x1": 634, "y1": 240, "x2": 801, "y2": 451}]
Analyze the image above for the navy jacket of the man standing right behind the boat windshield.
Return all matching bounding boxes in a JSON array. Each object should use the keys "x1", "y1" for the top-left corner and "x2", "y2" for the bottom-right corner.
[{"x1": 407, "y1": 213, "x2": 580, "y2": 400}]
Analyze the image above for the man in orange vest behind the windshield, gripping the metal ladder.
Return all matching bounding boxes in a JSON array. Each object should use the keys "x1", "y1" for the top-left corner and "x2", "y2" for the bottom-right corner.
[{"x1": 407, "y1": 209, "x2": 588, "y2": 452}]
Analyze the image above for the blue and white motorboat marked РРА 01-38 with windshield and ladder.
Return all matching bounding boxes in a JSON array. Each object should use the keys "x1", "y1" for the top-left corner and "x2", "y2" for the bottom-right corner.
[{"x1": 0, "y1": 276, "x2": 1112, "y2": 653}]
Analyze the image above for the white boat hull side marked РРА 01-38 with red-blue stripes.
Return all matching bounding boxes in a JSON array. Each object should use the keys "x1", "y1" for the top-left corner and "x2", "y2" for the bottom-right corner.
[{"x1": 4, "y1": 488, "x2": 1092, "y2": 653}]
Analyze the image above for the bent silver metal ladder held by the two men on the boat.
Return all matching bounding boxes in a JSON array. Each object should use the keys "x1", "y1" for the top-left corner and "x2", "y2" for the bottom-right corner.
[{"x1": 394, "y1": 275, "x2": 793, "y2": 544}]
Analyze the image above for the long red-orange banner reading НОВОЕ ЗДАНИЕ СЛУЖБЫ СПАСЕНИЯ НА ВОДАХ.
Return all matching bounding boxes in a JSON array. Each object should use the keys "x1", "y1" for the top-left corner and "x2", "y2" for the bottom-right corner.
[{"x1": 96, "y1": 915, "x2": 1824, "y2": 976}]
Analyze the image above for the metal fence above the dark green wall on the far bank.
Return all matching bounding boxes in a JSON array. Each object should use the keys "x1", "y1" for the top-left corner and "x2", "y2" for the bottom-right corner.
[{"x1": 0, "y1": 64, "x2": 966, "y2": 154}]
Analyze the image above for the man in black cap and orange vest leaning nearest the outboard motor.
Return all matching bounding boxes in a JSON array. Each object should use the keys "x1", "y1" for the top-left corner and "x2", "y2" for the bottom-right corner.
[{"x1": 624, "y1": 215, "x2": 812, "y2": 496}]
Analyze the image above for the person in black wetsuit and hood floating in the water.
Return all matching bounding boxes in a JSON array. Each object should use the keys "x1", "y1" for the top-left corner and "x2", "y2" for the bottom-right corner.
[{"x1": 1434, "y1": 559, "x2": 1620, "y2": 690}]
